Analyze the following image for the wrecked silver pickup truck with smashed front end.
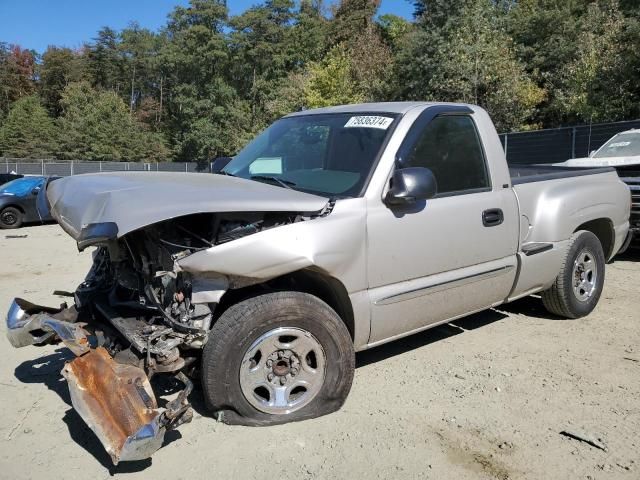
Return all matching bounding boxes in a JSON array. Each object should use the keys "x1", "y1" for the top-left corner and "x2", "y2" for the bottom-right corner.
[{"x1": 7, "y1": 103, "x2": 630, "y2": 463}]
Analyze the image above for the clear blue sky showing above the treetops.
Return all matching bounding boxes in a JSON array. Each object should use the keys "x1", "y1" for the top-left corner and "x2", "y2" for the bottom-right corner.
[{"x1": 0, "y1": 0, "x2": 413, "y2": 53}]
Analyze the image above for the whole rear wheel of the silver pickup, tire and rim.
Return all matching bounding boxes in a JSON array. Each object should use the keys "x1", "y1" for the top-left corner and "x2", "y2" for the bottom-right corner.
[{"x1": 542, "y1": 231, "x2": 605, "y2": 318}]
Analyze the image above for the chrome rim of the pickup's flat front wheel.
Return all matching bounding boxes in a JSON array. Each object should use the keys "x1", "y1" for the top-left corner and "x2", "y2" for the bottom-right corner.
[{"x1": 240, "y1": 327, "x2": 326, "y2": 415}]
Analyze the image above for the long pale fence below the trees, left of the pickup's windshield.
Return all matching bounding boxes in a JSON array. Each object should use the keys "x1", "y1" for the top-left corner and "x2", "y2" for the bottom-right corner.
[{"x1": 0, "y1": 157, "x2": 209, "y2": 176}]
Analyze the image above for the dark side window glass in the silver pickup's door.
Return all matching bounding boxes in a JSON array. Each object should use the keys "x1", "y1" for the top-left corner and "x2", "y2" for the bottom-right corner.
[{"x1": 406, "y1": 115, "x2": 490, "y2": 195}]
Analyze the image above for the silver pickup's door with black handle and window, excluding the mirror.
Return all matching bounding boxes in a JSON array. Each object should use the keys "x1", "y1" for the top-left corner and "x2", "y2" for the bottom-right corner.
[{"x1": 367, "y1": 109, "x2": 518, "y2": 345}]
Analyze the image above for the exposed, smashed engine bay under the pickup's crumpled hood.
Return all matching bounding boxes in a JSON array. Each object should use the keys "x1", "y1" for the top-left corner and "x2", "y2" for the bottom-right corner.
[{"x1": 75, "y1": 213, "x2": 308, "y2": 368}]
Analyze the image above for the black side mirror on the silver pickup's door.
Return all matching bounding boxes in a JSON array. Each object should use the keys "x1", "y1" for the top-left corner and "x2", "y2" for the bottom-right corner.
[{"x1": 384, "y1": 167, "x2": 438, "y2": 205}]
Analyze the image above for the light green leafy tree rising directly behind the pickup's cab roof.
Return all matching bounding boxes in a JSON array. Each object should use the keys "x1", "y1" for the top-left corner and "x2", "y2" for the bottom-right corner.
[{"x1": 399, "y1": 0, "x2": 545, "y2": 130}]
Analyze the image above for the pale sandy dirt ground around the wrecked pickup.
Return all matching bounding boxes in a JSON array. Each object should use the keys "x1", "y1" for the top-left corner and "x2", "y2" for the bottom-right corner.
[{"x1": 0, "y1": 225, "x2": 640, "y2": 480}]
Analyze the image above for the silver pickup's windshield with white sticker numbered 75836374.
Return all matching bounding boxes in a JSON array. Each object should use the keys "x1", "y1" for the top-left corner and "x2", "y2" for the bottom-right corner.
[{"x1": 223, "y1": 113, "x2": 396, "y2": 197}]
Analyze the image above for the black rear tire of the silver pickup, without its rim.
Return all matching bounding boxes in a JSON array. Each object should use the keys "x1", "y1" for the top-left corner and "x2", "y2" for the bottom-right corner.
[{"x1": 542, "y1": 230, "x2": 605, "y2": 318}]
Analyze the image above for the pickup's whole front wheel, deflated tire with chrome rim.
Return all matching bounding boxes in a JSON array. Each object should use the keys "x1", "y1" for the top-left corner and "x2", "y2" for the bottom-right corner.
[{"x1": 202, "y1": 292, "x2": 355, "y2": 425}]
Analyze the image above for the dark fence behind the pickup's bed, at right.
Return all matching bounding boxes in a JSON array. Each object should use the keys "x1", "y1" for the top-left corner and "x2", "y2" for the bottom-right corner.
[{"x1": 500, "y1": 120, "x2": 640, "y2": 164}]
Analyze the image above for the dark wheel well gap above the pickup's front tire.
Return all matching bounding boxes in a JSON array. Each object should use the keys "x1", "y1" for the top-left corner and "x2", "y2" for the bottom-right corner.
[{"x1": 216, "y1": 269, "x2": 355, "y2": 340}]
